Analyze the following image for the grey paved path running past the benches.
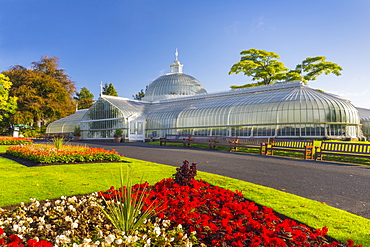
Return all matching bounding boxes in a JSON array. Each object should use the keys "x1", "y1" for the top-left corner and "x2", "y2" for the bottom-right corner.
[{"x1": 80, "y1": 142, "x2": 370, "y2": 219}]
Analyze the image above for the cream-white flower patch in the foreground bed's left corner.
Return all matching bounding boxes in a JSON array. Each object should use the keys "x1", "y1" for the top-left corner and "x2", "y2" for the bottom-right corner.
[{"x1": 0, "y1": 193, "x2": 197, "y2": 247}]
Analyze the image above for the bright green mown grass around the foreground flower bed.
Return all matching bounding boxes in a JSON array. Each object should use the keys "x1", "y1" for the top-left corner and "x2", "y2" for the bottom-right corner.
[{"x1": 0, "y1": 146, "x2": 370, "y2": 246}]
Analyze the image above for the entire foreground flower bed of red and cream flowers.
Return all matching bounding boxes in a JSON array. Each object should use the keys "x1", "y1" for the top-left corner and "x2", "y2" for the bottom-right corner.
[{"x1": 0, "y1": 161, "x2": 359, "y2": 247}]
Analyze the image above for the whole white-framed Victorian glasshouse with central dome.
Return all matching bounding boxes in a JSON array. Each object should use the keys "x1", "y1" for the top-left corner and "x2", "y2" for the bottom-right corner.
[{"x1": 47, "y1": 55, "x2": 370, "y2": 141}]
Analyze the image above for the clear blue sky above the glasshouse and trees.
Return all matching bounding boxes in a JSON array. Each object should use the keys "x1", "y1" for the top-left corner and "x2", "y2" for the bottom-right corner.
[{"x1": 0, "y1": 0, "x2": 370, "y2": 108}]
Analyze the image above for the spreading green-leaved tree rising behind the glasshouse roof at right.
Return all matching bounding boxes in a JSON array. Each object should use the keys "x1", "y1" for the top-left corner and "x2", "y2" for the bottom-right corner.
[{"x1": 229, "y1": 49, "x2": 342, "y2": 88}]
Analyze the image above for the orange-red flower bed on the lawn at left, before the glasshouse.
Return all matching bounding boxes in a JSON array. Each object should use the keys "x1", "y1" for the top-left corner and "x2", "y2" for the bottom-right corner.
[{"x1": 6, "y1": 144, "x2": 122, "y2": 164}]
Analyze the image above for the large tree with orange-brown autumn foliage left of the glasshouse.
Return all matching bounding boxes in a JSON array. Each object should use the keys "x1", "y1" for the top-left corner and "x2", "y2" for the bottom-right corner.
[{"x1": 3, "y1": 57, "x2": 75, "y2": 127}]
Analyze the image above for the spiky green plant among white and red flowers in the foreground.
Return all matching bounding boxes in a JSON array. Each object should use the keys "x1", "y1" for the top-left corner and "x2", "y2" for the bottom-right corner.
[{"x1": 100, "y1": 170, "x2": 160, "y2": 234}]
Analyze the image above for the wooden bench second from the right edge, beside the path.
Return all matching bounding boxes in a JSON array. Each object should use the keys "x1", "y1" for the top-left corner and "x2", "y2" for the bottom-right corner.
[{"x1": 266, "y1": 139, "x2": 313, "y2": 159}]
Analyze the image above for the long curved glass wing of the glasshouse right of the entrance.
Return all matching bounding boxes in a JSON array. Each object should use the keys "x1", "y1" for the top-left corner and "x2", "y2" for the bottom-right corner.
[{"x1": 147, "y1": 82, "x2": 360, "y2": 139}]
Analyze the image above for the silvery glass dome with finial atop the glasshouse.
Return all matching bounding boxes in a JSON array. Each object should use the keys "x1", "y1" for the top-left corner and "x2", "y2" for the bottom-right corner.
[{"x1": 143, "y1": 50, "x2": 207, "y2": 101}]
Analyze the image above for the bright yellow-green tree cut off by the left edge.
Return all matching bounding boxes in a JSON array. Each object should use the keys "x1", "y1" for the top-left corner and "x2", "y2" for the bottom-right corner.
[{"x1": 0, "y1": 74, "x2": 17, "y2": 127}]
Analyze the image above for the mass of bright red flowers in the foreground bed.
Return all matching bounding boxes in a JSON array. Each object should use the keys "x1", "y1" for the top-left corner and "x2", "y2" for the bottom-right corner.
[{"x1": 99, "y1": 179, "x2": 362, "y2": 247}]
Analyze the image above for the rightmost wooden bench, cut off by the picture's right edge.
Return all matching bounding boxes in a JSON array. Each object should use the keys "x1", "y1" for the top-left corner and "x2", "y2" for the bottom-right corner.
[{"x1": 315, "y1": 141, "x2": 370, "y2": 160}]
